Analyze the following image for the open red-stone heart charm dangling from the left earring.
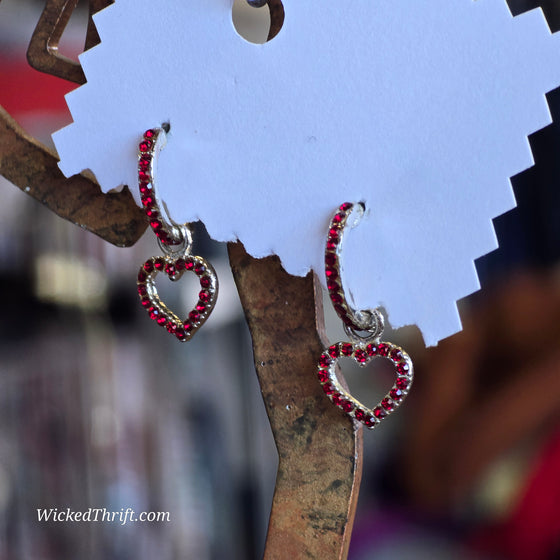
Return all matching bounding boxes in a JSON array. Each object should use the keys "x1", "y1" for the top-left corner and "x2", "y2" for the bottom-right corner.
[{"x1": 137, "y1": 255, "x2": 218, "y2": 342}]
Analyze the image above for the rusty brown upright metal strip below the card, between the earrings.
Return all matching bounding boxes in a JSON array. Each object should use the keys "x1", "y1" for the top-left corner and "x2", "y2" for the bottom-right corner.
[{"x1": 229, "y1": 243, "x2": 362, "y2": 560}]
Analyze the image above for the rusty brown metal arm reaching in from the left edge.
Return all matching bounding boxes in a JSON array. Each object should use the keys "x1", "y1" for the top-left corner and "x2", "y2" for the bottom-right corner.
[{"x1": 0, "y1": 107, "x2": 146, "y2": 247}]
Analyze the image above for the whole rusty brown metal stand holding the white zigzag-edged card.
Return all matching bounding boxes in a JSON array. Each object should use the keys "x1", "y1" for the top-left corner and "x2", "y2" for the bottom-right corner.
[{"x1": 0, "y1": 0, "x2": 362, "y2": 560}]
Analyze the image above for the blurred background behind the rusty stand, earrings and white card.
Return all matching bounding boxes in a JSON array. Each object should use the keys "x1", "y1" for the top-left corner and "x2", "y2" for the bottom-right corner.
[{"x1": 0, "y1": 0, "x2": 560, "y2": 560}]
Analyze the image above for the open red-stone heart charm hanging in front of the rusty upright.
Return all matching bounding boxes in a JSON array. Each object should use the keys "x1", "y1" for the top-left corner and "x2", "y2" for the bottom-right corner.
[{"x1": 317, "y1": 341, "x2": 413, "y2": 429}]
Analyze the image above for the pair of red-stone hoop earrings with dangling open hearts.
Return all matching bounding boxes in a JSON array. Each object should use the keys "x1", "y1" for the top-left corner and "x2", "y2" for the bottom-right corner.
[{"x1": 133, "y1": 128, "x2": 413, "y2": 429}]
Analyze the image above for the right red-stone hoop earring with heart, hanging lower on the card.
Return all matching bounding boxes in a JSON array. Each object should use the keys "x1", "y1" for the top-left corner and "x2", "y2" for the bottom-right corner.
[{"x1": 317, "y1": 202, "x2": 413, "y2": 429}]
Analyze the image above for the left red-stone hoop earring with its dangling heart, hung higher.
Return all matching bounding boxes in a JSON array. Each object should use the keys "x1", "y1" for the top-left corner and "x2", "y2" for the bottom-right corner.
[{"x1": 137, "y1": 128, "x2": 218, "y2": 342}]
